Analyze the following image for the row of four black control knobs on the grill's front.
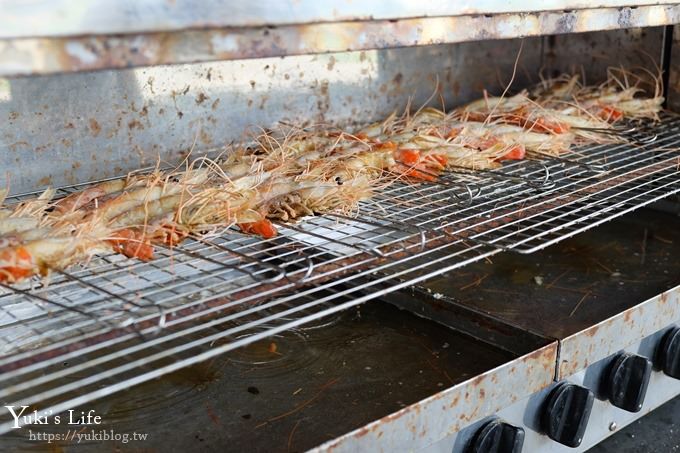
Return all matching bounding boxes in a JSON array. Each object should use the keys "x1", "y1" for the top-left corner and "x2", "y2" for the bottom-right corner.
[{"x1": 468, "y1": 326, "x2": 680, "y2": 453}]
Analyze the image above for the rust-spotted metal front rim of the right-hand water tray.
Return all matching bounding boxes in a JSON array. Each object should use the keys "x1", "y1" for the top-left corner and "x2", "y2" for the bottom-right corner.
[{"x1": 557, "y1": 286, "x2": 680, "y2": 379}]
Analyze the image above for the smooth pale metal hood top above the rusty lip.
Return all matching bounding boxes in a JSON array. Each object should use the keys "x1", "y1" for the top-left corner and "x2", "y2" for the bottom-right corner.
[{"x1": 0, "y1": 0, "x2": 672, "y2": 38}]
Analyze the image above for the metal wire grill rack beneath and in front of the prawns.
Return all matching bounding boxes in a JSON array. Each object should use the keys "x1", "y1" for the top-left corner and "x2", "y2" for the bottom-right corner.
[{"x1": 0, "y1": 115, "x2": 680, "y2": 432}]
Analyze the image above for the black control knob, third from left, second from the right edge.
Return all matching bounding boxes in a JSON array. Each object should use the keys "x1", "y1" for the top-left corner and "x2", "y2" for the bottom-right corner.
[{"x1": 604, "y1": 352, "x2": 652, "y2": 412}]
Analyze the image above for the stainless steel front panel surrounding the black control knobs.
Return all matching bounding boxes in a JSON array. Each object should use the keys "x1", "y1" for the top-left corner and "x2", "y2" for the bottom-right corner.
[{"x1": 424, "y1": 319, "x2": 680, "y2": 453}]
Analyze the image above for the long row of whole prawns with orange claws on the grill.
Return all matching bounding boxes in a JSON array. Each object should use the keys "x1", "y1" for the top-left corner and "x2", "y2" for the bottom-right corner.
[{"x1": 0, "y1": 68, "x2": 663, "y2": 283}]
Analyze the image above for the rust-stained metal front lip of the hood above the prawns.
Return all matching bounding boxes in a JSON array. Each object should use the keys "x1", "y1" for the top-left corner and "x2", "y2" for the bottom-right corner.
[{"x1": 0, "y1": 5, "x2": 680, "y2": 76}]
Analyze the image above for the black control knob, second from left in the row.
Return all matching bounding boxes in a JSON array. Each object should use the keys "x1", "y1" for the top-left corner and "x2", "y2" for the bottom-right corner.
[{"x1": 541, "y1": 381, "x2": 595, "y2": 448}]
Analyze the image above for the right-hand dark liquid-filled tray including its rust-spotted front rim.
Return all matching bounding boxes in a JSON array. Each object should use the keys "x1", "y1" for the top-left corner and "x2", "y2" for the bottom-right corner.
[{"x1": 410, "y1": 209, "x2": 680, "y2": 377}]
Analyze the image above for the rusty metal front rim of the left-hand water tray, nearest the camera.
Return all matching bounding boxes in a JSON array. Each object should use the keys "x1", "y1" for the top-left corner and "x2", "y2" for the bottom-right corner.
[{"x1": 311, "y1": 342, "x2": 557, "y2": 453}]
